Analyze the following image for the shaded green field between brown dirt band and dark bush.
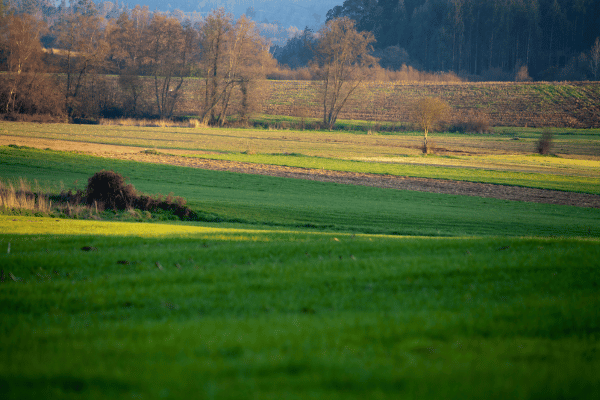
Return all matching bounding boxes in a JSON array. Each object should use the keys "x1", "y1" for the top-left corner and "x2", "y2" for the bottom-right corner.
[{"x1": 0, "y1": 147, "x2": 600, "y2": 238}]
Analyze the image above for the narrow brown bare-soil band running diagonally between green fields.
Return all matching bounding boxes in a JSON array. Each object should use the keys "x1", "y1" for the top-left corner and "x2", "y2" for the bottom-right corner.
[{"x1": 0, "y1": 136, "x2": 600, "y2": 208}]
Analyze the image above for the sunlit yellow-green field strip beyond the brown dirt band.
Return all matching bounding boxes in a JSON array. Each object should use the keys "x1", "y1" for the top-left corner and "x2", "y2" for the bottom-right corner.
[{"x1": 0, "y1": 122, "x2": 600, "y2": 194}]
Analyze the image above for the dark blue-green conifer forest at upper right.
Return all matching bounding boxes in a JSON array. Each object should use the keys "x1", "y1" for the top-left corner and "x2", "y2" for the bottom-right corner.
[{"x1": 327, "y1": 0, "x2": 600, "y2": 80}]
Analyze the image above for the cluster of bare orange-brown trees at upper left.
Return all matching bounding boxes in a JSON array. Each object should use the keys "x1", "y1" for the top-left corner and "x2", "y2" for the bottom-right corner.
[{"x1": 0, "y1": 0, "x2": 275, "y2": 124}]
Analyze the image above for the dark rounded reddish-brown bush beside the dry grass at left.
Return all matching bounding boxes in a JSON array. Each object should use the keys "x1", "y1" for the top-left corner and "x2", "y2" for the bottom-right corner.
[{"x1": 86, "y1": 170, "x2": 137, "y2": 210}]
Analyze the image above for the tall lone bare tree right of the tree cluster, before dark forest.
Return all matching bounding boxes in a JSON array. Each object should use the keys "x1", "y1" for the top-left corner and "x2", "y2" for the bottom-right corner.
[{"x1": 317, "y1": 17, "x2": 377, "y2": 129}]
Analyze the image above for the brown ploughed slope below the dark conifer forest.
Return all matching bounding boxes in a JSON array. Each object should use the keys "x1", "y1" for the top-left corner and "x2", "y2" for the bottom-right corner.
[{"x1": 263, "y1": 81, "x2": 600, "y2": 128}]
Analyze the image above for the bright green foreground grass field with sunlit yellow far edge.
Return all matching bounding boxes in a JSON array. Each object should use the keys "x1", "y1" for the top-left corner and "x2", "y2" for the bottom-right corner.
[{"x1": 0, "y1": 217, "x2": 600, "y2": 400}]
